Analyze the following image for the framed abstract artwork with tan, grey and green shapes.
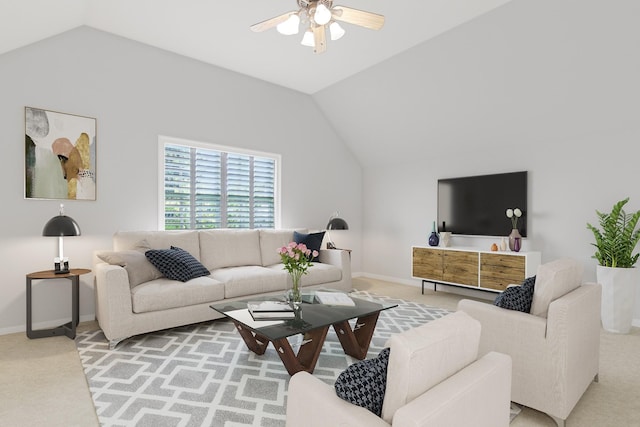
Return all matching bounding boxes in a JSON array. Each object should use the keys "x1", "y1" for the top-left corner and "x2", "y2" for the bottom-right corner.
[{"x1": 24, "y1": 107, "x2": 96, "y2": 200}]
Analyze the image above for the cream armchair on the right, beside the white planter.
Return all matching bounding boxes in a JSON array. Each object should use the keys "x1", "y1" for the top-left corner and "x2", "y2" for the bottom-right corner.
[{"x1": 458, "y1": 259, "x2": 601, "y2": 426}]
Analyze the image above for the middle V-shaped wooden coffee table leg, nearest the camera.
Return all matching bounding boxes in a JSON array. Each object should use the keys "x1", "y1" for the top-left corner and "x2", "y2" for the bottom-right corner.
[{"x1": 273, "y1": 326, "x2": 329, "y2": 375}]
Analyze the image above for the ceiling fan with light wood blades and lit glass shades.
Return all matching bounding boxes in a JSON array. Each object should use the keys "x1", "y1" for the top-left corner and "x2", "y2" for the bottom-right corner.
[{"x1": 250, "y1": 0, "x2": 384, "y2": 53}]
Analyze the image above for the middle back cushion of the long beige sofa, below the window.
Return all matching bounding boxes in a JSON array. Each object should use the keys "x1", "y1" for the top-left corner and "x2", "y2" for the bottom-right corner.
[{"x1": 200, "y1": 229, "x2": 262, "y2": 270}]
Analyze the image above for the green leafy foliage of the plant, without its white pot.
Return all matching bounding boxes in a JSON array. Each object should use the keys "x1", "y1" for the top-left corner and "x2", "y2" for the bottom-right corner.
[{"x1": 587, "y1": 197, "x2": 640, "y2": 268}]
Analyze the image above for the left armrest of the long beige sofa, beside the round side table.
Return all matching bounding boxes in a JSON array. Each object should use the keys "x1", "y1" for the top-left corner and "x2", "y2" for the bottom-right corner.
[{"x1": 94, "y1": 263, "x2": 133, "y2": 341}]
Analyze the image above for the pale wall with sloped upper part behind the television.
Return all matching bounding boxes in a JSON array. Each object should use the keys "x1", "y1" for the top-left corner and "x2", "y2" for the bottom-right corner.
[{"x1": 314, "y1": 0, "x2": 640, "y2": 325}]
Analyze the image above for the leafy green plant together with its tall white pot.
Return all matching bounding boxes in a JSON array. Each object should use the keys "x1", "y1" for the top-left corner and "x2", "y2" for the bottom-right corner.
[{"x1": 587, "y1": 197, "x2": 640, "y2": 333}]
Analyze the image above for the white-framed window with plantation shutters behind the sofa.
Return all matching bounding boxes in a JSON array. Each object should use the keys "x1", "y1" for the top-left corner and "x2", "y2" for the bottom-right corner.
[{"x1": 159, "y1": 137, "x2": 280, "y2": 230}]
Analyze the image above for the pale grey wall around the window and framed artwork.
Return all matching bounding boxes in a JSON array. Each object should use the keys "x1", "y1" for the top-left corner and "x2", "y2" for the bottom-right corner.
[{"x1": 0, "y1": 27, "x2": 362, "y2": 333}]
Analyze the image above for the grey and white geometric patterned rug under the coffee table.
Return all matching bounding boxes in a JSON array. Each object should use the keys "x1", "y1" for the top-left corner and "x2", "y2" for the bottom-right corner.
[{"x1": 76, "y1": 291, "x2": 449, "y2": 427}]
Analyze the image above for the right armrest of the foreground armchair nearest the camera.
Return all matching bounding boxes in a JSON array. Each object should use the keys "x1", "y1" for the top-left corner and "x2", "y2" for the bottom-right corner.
[{"x1": 393, "y1": 352, "x2": 511, "y2": 427}]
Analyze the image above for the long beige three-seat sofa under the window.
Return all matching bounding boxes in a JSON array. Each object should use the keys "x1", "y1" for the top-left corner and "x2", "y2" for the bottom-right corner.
[{"x1": 93, "y1": 229, "x2": 352, "y2": 348}]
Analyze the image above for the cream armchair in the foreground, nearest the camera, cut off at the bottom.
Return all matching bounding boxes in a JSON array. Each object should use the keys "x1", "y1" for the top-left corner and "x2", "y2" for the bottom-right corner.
[{"x1": 287, "y1": 312, "x2": 511, "y2": 427}]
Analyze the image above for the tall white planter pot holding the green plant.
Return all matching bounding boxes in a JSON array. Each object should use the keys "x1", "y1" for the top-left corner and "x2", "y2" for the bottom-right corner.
[{"x1": 596, "y1": 265, "x2": 640, "y2": 334}]
